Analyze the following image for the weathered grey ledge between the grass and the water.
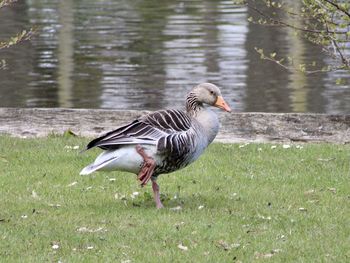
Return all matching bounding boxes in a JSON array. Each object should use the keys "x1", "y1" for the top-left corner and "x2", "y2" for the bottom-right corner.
[{"x1": 0, "y1": 108, "x2": 350, "y2": 143}]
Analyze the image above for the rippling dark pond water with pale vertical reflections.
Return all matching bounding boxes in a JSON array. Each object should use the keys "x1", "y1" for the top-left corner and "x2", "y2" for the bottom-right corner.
[{"x1": 0, "y1": 0, "x2": 350, "y2": 113}]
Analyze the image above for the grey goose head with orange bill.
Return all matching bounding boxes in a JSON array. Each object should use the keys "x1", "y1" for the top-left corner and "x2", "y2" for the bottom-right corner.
[{"x1": 187, "y1": 83, "x2": 231, "y2": 112}]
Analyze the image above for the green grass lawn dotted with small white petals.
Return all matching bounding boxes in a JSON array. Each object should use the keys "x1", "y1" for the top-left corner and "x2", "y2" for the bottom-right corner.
[{"x1": 0, "y1": 136, "x2": 350, "y2": 262}]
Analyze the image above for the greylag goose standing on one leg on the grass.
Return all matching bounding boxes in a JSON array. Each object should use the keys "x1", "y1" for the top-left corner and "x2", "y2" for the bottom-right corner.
[{"x1": 80, "y1": 83, "x2": 231, "y2": 208}]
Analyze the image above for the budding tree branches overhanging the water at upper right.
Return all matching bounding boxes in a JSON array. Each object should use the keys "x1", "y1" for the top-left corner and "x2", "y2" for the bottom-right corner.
[{"x1": 246, "y1": 0, "x2": 350, "y2": 74}]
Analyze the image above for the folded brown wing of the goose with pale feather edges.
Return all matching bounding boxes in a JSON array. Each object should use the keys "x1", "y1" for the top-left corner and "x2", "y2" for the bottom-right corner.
[{"x1": 87, "y1": 110, "x2": 191, "y2": 150}]
